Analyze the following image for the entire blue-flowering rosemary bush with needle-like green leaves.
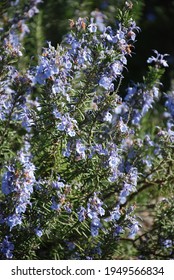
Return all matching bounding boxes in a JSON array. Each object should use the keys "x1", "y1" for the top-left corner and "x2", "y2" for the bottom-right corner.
[{"x1": 0, "y1": 0, "x2": 174, "y2": 259}]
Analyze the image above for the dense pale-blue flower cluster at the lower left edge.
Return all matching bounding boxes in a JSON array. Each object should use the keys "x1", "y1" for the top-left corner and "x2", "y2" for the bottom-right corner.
[{"x1": 2, "y1": 142, "x2": 35, "y2": 231}]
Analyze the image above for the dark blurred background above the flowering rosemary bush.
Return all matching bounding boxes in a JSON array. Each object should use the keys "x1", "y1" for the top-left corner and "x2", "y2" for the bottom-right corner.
[{"x1": 25, "y1": 0, "x2": 174, "y2": 92}]
